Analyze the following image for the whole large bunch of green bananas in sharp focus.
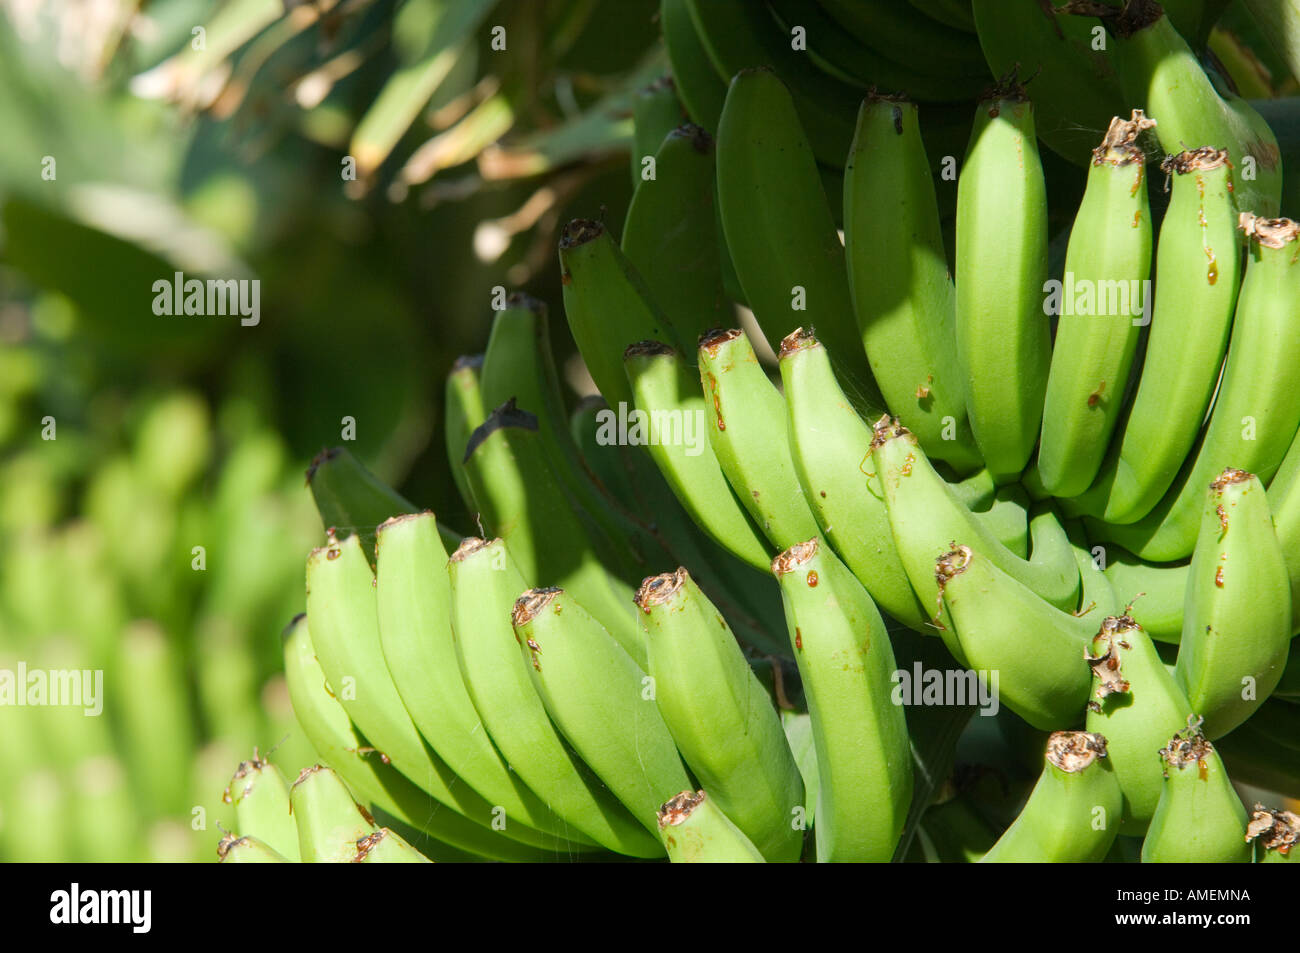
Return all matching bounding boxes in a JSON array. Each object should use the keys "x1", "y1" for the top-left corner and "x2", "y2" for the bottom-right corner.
[{"x1": 274, "y1": 0, "x2": 1300, "y2": 862}]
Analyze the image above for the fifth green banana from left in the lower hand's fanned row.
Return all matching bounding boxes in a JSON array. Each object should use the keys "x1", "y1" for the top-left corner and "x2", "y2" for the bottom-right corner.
[{"x1": 511, "y1": 588, "x2": 690, "y2": 835}]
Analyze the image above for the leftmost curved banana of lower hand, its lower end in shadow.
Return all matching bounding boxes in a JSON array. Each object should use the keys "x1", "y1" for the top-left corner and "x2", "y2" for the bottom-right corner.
[{"x1": 283, "y1": 614, "x2": 517, "y2": 862}]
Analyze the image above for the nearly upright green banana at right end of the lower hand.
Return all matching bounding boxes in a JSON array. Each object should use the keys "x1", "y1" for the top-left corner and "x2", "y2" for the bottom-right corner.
[{"x1": 772, "y1": 538, "x2": 913, "y2": 862}]
